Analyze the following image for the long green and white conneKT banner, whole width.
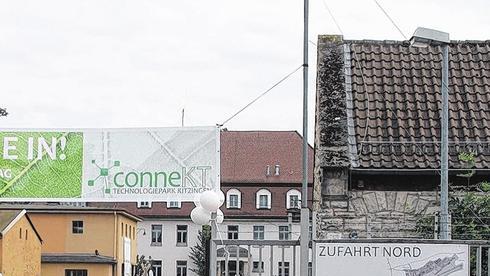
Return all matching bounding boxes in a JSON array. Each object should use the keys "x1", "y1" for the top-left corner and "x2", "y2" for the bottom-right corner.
[{"x1": 0, "y1": 127, "x2": 220, "y2": 202}]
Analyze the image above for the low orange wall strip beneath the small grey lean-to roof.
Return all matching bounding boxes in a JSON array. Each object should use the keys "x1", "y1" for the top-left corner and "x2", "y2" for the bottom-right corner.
[{"x1": 42, "y1": 263, "x2": 113, "y2": 276}]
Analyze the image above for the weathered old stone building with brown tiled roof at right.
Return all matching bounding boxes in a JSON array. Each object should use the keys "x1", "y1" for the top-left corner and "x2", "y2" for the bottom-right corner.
[{"x1": 313, "y1": 35, "x2": 490, "y2": 239}]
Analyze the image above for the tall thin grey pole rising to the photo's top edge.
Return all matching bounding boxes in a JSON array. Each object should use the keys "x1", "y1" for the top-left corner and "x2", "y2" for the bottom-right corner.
[{"x1": 299, "y1": 0, "x2": 310, "y2": 276}]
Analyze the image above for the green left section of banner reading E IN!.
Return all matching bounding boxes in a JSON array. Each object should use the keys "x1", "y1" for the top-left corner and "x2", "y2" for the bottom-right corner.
[{"x1": 0, "y1": 132, "x2": 83, "y2": 198}]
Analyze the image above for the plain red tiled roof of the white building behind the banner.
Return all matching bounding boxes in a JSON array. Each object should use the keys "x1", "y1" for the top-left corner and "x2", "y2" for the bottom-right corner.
[{"x1": 221, "y1": 131, "x2": 313, "y2": 184}]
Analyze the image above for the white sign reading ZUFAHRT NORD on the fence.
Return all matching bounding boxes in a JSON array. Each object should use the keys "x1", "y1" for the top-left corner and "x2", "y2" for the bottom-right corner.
[{"x1": 315, "y1": 243, "x2": 469, "y2": 276}]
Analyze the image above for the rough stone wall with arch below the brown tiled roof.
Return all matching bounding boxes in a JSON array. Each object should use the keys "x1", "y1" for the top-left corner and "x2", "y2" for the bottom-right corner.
[{"x1": 314, "y1": 191, "x2": 439, "y2": 239}]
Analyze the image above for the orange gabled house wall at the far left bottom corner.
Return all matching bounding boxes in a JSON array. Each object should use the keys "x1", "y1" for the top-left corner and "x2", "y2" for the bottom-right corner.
[{"x1": 0, "y1": 216, "x2": 41, "y2": 276}]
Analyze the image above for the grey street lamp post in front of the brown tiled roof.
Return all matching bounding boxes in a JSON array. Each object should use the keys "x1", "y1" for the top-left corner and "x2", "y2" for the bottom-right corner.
[{"x1": 410, "y1": 27, "x2": 451, "y2": 240}]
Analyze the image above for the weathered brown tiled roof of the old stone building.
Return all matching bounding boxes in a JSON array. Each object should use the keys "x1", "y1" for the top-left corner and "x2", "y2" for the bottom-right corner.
[{"x1": 317, "y1": 36, "x2": 490, "y2": 170}]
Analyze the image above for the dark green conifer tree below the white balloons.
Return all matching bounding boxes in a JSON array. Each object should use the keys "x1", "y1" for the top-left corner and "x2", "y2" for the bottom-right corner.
[{"x1": 189, "y1": 225, "x2": 211, "y2": 276}]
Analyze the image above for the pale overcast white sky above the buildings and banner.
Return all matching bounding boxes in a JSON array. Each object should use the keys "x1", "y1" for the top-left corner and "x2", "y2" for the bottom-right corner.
[{"x1": 0, "y1": 0, "x2": 490, "y2": 141}]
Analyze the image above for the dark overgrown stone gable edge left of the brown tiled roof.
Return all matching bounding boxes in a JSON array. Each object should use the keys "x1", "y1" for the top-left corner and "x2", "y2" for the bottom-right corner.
[{"x1": 313, "y1": 35, "x2": 350, "y2": 209}]
